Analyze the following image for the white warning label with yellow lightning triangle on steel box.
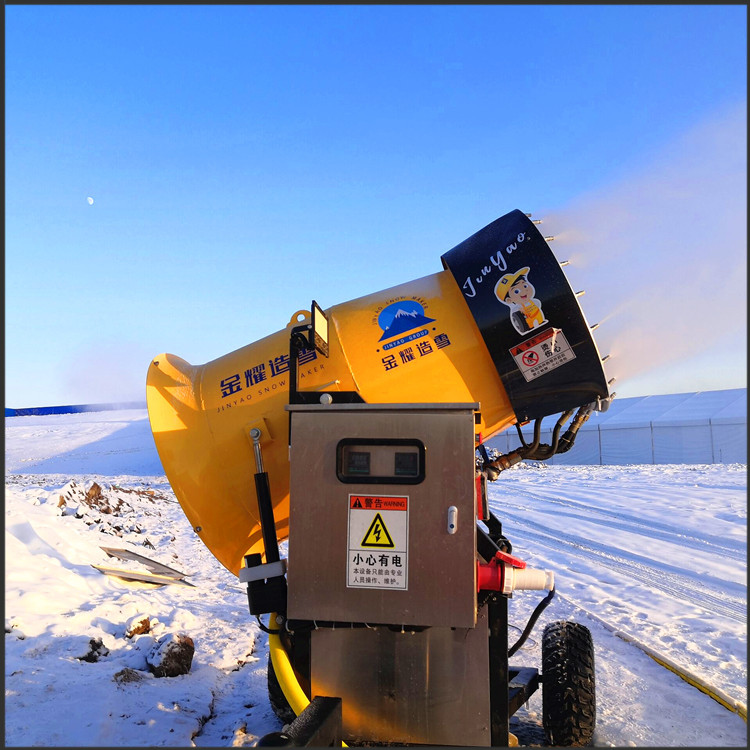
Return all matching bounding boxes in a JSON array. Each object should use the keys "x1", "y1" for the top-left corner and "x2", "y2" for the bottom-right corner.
[{"x1": 346, "y1": 495, "x2": 409, "y2": 591}]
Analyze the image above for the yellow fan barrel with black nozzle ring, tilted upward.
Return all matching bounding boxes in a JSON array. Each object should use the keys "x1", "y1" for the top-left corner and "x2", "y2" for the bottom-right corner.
[{"x1": 146, "y1": 211, "x2": 608, "y2": 574}]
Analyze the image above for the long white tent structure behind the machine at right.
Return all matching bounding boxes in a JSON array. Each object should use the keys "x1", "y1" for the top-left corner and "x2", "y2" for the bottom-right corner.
[{"x1": 487, "y1": 388, "x2": 747, "y2": 465}]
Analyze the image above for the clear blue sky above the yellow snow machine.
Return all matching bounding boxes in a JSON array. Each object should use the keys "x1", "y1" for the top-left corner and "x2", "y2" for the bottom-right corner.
[{"x1": 5, "y1": 5, "x2": 747, "y2": 407}]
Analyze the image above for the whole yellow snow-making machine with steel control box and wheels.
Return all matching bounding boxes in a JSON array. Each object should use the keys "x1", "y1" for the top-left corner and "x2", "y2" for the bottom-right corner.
[{"x1": 147, "y1": 210, "x2": 614, "y2": 746}]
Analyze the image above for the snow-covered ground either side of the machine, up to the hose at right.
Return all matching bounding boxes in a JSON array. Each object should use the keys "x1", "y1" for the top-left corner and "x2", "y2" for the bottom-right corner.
[{"x1": 5, "y1": 410, "x2": 747, "y2": 747}]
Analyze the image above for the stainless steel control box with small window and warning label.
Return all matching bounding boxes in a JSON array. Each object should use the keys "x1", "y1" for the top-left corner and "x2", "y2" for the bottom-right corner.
[{"x1": 287, "y1": 404, "x2": 478, "y2": 628}]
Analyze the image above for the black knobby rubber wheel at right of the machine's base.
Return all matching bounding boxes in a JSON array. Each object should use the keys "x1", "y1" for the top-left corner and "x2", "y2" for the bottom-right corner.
[{"x1": 542, "y1": 621, "x2": 596, "y2": 747}]
